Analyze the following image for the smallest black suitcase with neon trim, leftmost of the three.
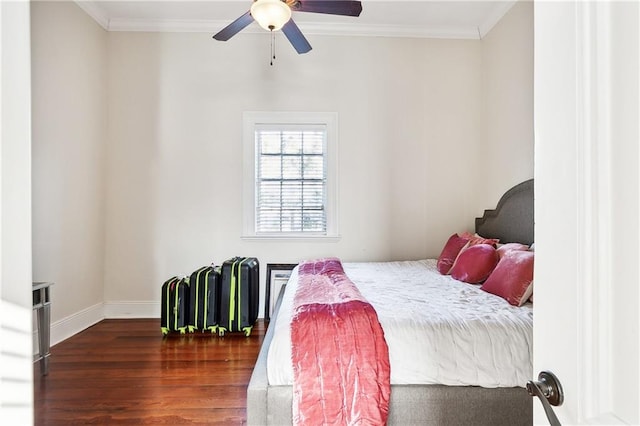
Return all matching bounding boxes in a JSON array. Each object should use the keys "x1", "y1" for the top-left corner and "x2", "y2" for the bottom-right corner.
[{"x1": 160, "y1": 277, "x2": 189, "y2": 335}]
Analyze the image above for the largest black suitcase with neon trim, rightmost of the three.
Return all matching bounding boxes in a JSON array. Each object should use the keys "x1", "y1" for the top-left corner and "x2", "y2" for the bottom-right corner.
[{"x1": 218, "y1": 257, "x2": 260, "y2": 336}]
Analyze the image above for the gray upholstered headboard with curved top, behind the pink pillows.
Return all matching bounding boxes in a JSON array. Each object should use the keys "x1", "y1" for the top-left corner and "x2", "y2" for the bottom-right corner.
[{"x1": 476, "y1": 179, "x2": 534, "y2": 245}]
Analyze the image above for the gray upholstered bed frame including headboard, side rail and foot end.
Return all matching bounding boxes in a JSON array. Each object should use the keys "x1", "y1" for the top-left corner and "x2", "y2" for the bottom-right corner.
[{"x1": 247, "y1": 179, "x2": 534, "y2": 426}]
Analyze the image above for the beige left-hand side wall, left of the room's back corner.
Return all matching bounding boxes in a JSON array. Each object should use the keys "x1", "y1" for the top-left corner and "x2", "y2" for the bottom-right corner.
[{"x1": 31, "y1": 2, "x2": 107, "y2": 330}]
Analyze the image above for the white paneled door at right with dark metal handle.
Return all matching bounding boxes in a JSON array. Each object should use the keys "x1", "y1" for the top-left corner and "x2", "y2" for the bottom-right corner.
[{"x1": 534, "y1": 1, "x2": 640, "y2": 424}]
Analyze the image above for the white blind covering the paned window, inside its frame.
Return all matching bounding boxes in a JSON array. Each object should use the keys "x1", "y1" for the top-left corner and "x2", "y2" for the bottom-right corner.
[{"x1": 255, "y1": 125, "x2": 327, "y2": 235}]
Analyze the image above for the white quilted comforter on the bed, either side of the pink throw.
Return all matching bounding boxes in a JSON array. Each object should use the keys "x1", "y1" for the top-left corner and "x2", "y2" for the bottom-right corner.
[{"x1": 267, "y1": 259, "x2": 533, "y2": 388}]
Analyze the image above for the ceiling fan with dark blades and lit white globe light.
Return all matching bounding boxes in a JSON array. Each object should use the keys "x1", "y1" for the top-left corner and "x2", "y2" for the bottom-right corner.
[{"x1": 213, "y1": 0, "x2": 362, "y2": 53}]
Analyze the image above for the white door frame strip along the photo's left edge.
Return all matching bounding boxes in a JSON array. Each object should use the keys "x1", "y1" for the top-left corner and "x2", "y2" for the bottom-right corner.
[{"x1": 0, "y1": 1, "x2": 33, "y2": 425}]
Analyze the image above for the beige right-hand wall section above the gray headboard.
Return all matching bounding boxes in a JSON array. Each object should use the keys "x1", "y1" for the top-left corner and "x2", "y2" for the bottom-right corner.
[{"x1": 478, "y1": 1, "x2": 534, "y2": 206}]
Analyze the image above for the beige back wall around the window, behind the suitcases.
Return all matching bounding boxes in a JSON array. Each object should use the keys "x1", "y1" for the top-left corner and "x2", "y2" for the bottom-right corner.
[{"x1": 105, "y1": 33, "x2": 482, "y2": 310}]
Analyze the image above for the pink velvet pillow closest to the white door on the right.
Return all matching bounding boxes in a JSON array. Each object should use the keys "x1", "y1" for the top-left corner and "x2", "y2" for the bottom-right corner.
[{"x1": 481, "y1": 250, "x2": 534, "y2": 306}]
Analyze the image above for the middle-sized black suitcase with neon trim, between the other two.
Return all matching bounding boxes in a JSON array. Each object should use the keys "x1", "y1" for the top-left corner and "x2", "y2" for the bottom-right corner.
[{"x1": 189, "y1": 265, "x2": 222, "y2": 333}]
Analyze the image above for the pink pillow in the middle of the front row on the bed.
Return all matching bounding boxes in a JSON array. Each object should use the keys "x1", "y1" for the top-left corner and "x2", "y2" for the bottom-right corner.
[{"x1": 451, "y1": 244, "x2": 500, "y2": 284}]
